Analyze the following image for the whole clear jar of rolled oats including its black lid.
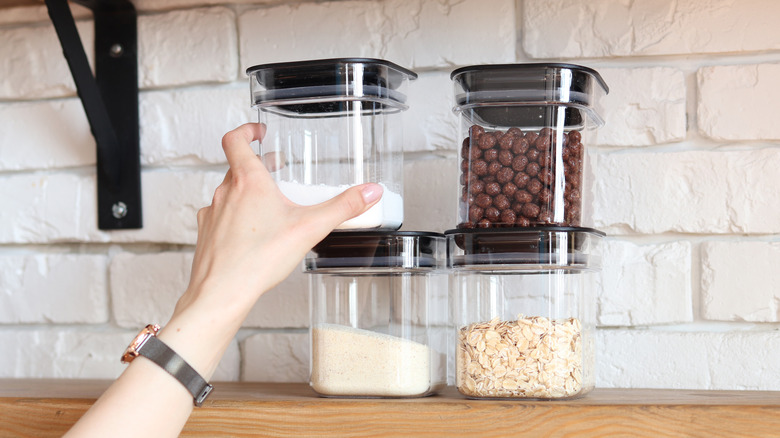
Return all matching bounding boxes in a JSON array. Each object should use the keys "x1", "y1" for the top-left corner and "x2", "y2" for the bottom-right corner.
[{"x1": 445, "y1": 227, "x2": 604, "y2": 400}]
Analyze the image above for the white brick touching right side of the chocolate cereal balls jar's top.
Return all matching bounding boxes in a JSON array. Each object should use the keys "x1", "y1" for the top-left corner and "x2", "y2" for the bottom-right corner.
[{"x1": 592, "y1": 67, "x2": 686, "y2": 146}]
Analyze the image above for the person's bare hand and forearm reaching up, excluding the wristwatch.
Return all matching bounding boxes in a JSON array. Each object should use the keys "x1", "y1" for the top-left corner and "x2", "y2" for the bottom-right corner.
[{"x1": 67, "y1": 123, "x2": 382, "y2": 437}]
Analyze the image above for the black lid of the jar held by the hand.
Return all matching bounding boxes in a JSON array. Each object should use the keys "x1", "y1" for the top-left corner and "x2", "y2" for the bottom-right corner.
[{"x1": 246, "y1": 58, "x2": 417, "y2": 115}]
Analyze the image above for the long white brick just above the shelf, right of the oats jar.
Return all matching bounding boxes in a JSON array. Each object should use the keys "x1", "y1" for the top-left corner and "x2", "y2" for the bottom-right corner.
[{"x1": 596, "y1": 330, "x2": 780, "y2": 391}]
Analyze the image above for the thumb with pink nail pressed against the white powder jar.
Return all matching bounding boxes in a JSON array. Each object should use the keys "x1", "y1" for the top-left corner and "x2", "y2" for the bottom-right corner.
[{"x1": 311, "y1": 183, "x2": 384, "y2": 232}]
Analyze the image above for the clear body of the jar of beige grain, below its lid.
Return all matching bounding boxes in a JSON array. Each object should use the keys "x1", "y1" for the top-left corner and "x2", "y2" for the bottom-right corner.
[{"x1": 310, "y1": 272, "x2": 448, "y2": 397}]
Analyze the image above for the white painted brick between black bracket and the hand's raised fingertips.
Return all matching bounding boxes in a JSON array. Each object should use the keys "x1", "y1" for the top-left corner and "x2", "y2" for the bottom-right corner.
[{"x1": 139, "y1": 83, "x2": 257, "y2": 165}]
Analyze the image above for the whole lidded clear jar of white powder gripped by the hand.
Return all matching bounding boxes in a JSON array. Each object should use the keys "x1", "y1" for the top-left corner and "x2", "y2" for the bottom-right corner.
[{"x1": 247, "y1": 58, "x2": 417, "y2": 230}]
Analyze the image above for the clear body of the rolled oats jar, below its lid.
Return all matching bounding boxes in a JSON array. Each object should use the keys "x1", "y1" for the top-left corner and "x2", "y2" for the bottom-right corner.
[{"x1": 453, "y1": 270, "x2": 595, "y2": 399}]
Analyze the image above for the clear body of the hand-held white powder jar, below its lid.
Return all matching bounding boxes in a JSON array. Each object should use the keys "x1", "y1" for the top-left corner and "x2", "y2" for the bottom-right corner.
[{"x1": 259, "y1": 106, "x2": 404, "y2": 230}]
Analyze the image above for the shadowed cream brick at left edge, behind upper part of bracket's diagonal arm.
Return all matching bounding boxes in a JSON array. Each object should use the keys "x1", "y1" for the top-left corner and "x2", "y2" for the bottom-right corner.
[{"x1": 0, "y1": 21, "x2": 94, "y2": 99}]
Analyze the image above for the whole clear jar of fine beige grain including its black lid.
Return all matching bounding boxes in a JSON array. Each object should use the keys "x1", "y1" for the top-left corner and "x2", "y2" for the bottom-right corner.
[{"x1": 304, "y1": 232, "x2": 450, "y2": 398}]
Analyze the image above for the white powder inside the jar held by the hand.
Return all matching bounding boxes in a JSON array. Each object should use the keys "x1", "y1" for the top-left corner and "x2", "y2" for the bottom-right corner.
[{"x1": 277, "y1": 181, "x2": 404, "y2": 230}]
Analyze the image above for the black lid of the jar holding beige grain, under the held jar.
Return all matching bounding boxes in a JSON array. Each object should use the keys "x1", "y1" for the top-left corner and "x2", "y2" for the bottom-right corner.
[{"x1": 305, "y1": 231, "x2": 445, "y2": 273}]
